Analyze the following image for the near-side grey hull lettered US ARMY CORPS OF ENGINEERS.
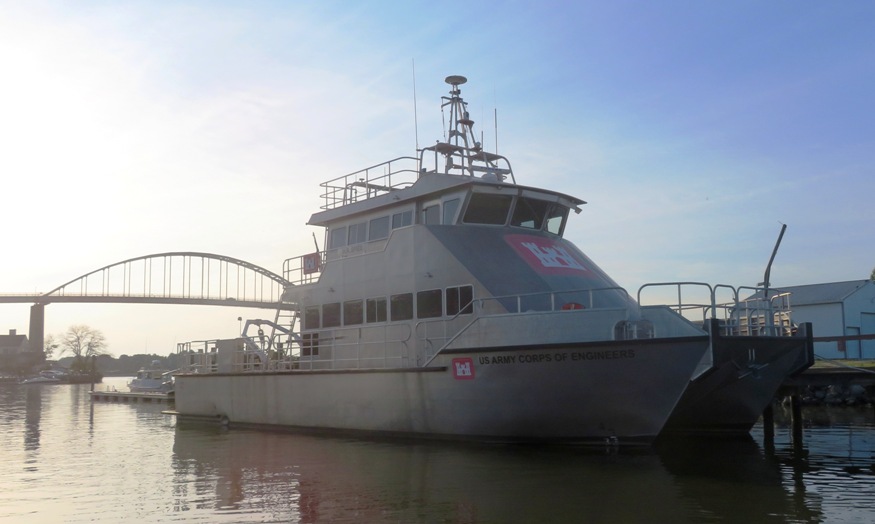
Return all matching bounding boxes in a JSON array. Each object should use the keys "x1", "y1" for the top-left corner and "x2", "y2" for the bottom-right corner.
[{"x1": 175, "y1": 337, "x2": 707, "y2": 444}]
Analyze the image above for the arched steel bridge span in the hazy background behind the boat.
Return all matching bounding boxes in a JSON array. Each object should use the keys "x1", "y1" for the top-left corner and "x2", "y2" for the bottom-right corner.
[{"x1": 0, "y1": 251, "x2": 295, "y2": 351}]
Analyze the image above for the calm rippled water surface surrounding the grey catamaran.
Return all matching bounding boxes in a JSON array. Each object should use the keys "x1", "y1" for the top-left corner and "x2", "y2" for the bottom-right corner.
[{"x1": 0, "y1": 378, "x2": 875, "y2": 524}]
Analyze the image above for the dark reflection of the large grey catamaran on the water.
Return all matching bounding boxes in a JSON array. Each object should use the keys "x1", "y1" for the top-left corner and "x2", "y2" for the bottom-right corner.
[{"x1": 171, "y1": 422, "x2": 696, "y2": 523}]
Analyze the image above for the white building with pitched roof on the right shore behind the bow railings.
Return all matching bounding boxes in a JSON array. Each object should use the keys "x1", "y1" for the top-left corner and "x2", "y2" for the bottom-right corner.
[{"x1": 769, "y1": 280, "x2": 875, "y2": 359}]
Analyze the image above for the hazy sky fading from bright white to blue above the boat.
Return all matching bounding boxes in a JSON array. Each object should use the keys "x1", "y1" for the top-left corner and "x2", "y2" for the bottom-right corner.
[{"x1": 0, "y1": 0, "x2": 875, "y2": 355}]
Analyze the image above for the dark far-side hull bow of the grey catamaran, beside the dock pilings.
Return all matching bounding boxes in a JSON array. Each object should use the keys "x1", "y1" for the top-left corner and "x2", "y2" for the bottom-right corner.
[{"x1": 664, "y1": 324, "x2": 814, "y2": 435}]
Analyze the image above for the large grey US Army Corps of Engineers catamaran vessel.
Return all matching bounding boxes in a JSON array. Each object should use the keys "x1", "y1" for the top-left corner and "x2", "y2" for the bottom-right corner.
[{"x1": 176, "y1": 76, "x2": 816, "y2": 444}]
